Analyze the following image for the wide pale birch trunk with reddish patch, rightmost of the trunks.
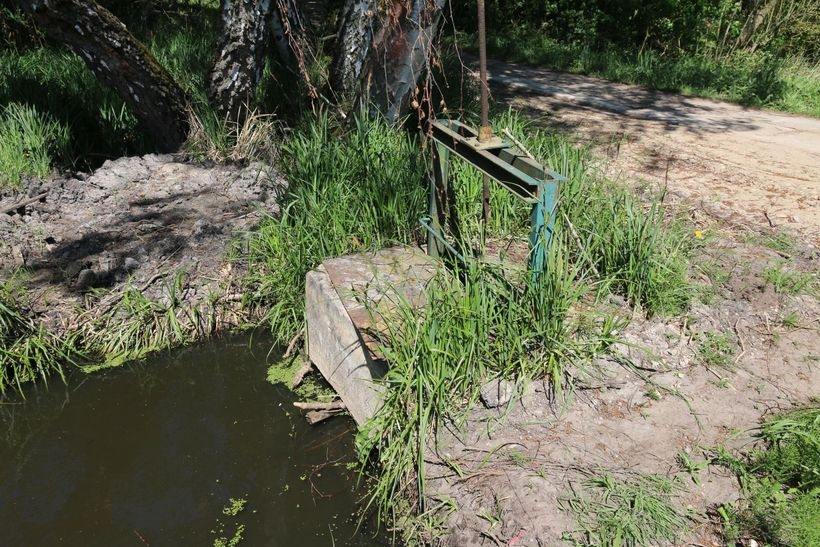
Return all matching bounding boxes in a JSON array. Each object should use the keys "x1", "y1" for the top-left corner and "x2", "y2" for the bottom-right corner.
[{"x1": 331, "y1": 0, "x2": 447, "y2": 123}]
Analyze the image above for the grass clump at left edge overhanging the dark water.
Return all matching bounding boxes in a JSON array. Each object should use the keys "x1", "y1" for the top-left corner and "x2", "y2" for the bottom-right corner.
[{"x1": 0, "y1": 283, "x2": 77, "y2": 395}]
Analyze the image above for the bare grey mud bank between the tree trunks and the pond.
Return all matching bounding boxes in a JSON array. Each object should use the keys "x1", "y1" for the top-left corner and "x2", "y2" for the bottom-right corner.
[{"x1": 0, "y1": 155, "x2": 286, "y2": 330}]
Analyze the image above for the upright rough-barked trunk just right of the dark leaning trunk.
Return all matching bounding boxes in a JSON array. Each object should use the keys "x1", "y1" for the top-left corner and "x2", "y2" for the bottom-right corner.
[{"x1": 209, "y1": 0, "x2": 272, "y2": 126}]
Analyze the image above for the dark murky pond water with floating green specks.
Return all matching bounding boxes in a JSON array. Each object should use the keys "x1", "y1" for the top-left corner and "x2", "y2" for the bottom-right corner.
[{"x1": 0, "y1": 336, "x2": 386, "y2": 547}]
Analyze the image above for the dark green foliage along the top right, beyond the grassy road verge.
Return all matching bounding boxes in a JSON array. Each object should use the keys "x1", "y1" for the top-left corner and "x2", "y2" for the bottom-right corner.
[{"x1": 453, "y1": 0, "x2": 820, "y2": 61}]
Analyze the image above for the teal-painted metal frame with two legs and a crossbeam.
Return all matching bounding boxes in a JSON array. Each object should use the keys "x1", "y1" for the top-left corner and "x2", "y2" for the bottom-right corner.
[{"x1": 422, "y1": 120, "x2": 566, "y2": 281}]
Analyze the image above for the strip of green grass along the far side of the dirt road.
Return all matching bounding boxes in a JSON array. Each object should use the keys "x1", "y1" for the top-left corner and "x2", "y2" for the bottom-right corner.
[{"x1": 457, "y1": 28, "x2": 820, "y2": 117}]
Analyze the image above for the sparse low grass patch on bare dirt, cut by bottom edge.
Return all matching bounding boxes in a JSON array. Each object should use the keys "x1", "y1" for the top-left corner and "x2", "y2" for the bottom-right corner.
[{"x1": 560, "y1": 472, "x2": 687, "y2": 547}]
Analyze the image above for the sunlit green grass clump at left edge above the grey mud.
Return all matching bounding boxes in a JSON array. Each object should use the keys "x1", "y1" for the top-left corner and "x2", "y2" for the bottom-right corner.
[{"x1": 0, "y1": 103, "x2": 71, "y2": 187}]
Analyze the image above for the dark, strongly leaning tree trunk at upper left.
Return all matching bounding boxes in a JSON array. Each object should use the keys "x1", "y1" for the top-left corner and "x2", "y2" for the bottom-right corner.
[{"x1": 18, "y1": 0, "x2": 188, "y2": 152}]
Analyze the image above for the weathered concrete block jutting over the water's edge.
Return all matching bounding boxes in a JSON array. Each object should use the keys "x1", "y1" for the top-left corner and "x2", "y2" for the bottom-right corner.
[{"x1": 305, "y1": 247, "x2": 436, "y2": 426}]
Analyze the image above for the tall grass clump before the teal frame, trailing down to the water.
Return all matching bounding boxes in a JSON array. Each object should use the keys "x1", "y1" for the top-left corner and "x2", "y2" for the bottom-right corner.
[{"x1": 357, "y1": 255, "x2": 614, "y2": 517}]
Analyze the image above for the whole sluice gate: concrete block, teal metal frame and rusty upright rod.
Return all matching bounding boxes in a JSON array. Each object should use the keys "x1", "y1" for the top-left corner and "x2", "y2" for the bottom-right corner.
[{"x1": 305, "y1": 0, "x2": 565, "y2": 426}]
